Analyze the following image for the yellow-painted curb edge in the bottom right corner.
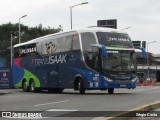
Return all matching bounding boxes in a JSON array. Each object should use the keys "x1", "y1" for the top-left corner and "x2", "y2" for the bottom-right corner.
[{"x1": 101, "y1": 101, "x2": 160, "y2": 120}]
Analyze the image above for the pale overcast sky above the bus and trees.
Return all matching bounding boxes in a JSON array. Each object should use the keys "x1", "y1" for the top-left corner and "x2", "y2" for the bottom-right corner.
[{"x1": 0, "y1": 0, "x2": 160, "y2": 54}]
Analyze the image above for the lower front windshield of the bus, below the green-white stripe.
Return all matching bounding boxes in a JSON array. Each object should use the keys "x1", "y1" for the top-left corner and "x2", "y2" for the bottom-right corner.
[{"x1": 102, "y1": 50, "x2": 137, "y2": 73}]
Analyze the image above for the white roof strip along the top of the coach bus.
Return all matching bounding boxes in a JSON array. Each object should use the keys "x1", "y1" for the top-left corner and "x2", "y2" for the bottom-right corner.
[{"x1": 13, "y1": 27, "x2": 125, "y2": 47}]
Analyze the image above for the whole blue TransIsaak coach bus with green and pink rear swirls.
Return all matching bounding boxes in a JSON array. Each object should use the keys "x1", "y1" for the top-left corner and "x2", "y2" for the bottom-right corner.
[{"x1": 12, "y1": 27, "x2": 145, "y2": 94}]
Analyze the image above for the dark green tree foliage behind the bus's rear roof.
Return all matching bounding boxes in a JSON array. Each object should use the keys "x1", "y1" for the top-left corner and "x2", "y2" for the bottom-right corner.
[{"x1": 0, "y1": 22, "x2": 62, "y2": 66}]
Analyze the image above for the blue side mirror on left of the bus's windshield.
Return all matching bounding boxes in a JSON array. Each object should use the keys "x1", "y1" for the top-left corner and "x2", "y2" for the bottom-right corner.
[{"x1": 91, "y1": 44, "x2": 107, "y2": 59}]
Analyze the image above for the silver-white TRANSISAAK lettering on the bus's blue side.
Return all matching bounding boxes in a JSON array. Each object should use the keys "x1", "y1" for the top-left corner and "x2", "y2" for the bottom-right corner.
[{"x1": 32, "y1": 54, "x2": 67, "y2": 65}]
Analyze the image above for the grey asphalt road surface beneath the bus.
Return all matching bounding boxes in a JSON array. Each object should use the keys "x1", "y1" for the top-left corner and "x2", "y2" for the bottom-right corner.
[{"x1": 0, "y1": 86, "x2": 160, "y2": 120}]
